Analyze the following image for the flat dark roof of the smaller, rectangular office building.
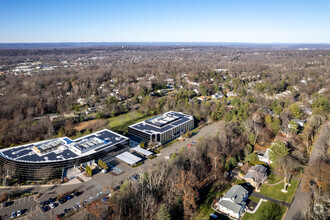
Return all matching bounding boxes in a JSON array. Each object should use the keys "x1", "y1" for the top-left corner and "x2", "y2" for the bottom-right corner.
[{"x1": 129, "y1": 111, "x2": 193, "y2": 134}]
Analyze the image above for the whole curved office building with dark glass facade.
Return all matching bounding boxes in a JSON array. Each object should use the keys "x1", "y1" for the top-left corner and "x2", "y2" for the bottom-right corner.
[{"x1": 0, "y1": 129, "x2": 129, "y2": 181}]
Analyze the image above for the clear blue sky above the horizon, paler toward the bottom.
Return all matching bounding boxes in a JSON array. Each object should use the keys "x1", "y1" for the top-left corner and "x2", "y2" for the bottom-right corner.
[{"x1": 0, "y1": 0, "x2": 330, "y2": 43}]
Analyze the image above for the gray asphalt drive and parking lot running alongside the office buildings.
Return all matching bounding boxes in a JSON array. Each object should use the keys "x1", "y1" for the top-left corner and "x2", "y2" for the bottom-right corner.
[{"x1": 0, "y1": 122, "x2": 221, "y2": 220}]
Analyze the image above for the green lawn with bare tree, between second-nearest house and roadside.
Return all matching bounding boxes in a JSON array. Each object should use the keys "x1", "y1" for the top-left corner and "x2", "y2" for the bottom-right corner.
[{"x1": 260, "y1": 179, "x2": 299, "y2": 203}]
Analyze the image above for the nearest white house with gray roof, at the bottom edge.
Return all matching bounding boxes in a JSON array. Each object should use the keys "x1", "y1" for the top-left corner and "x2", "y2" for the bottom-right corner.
[{"x1": 212, "y1": 185, "x2": 249, "y2": 219}]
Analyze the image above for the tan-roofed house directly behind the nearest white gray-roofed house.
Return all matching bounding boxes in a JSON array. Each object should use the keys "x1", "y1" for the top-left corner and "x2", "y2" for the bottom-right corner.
[{"x1": 243, "y1": 165, "x2": 267, "y2": 189}]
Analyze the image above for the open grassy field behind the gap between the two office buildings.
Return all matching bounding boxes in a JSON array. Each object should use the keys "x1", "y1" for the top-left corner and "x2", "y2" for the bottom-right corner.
[{"x1": 107, "y1": 111, "x2": 153, "y2": 134}]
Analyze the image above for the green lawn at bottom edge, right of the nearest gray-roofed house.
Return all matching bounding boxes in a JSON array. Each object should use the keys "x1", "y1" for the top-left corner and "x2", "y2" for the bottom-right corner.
[{"x1": 242, "y1": 201, "x2": 287, "y2": 220}]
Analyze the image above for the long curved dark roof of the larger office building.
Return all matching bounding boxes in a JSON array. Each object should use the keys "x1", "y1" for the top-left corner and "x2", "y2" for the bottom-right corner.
[{"x1": 0, "y1": 129, "x2": 128, "y2": 162}]
